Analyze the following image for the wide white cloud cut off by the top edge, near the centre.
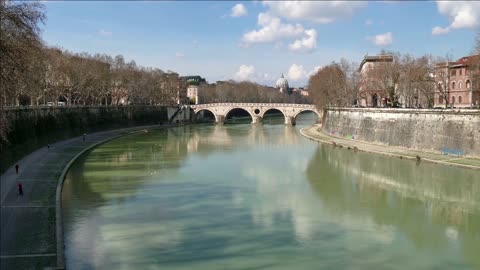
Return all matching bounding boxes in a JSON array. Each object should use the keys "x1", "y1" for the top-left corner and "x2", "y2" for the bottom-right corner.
[{"x1": 263, "y1": 1, "x2": 367, "y2": 23}]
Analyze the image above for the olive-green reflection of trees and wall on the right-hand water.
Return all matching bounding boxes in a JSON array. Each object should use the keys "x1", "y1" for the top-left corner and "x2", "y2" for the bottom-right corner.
[{"x1": 307, "y1": 146, "x2": 480, "y2": 269}]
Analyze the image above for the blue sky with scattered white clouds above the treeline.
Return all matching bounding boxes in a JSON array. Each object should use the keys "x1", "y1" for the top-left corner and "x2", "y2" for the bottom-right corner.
[{"x1": 42, "y1": 1, "x2": 480, "y2": 87}]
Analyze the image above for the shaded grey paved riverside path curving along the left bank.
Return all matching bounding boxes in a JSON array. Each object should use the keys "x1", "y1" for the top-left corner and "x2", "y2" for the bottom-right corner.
[{"x1": 0, "y1": 125, "x2": 168, "y2": 270}]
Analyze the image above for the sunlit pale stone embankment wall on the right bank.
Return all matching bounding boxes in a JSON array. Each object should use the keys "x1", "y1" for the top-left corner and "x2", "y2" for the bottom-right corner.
[{"x1": 322, "y1": 108, "x2": 480, "y2": 157}]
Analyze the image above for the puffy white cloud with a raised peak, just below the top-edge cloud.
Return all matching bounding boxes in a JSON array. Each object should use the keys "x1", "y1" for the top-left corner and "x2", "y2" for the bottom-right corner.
[{"x1": 242, "y1": 13, "x2": 304, "y2": 43}]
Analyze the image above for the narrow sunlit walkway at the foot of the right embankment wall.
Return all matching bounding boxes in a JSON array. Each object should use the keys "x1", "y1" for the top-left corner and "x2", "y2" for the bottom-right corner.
[{"x1": 300, "y1": 125, "x2": 480, "y2": 170}]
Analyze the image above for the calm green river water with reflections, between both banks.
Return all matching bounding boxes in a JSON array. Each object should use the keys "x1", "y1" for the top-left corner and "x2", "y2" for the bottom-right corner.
[{"x1": 62, "y1": 114, "x2": 480, "y2": 270}]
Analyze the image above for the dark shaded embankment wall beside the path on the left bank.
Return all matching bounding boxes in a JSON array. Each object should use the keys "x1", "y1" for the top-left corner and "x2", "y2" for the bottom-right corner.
[{"x1": 0, "y1": 106, "x2": 168, "y2": 172}]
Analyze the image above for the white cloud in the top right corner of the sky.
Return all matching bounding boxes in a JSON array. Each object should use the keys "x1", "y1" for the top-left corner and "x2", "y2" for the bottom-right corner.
[{"x1": 432, "y1": 1, "x2": 480, "y2": 35}]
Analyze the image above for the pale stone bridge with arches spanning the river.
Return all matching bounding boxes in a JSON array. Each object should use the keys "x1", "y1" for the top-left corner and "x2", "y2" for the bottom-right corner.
[{"x1": 190, "y1": 103, "x2": 322, "y2": 125}]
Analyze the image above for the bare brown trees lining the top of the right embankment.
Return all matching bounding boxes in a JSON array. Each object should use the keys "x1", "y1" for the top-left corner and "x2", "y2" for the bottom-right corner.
[{"x1": 308, "y1": 36, "x2": 480, "y2": 108}]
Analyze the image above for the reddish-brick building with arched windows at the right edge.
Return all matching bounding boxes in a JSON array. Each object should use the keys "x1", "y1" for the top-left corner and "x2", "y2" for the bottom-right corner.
[{"x1": 434, "y1": 55, "x2": 480, "y2": 108}]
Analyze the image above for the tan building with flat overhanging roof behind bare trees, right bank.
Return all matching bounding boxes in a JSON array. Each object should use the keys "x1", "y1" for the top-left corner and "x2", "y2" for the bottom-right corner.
[{"x1": 358, "y1": 54, "x2": 395, "y2": 107}]
